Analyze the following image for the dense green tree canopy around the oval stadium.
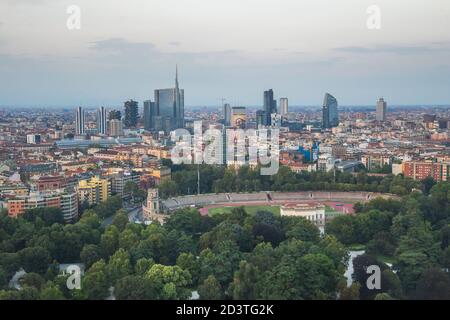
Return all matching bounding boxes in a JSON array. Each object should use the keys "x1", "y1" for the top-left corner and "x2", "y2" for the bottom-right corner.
[{"x1": 0, "y1": 178, "x2": 450, "y2": 300}]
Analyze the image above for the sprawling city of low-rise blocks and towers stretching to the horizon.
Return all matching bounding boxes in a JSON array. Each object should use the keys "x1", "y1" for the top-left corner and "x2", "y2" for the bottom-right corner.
[{"x1": 0, "y1": 66, "x2": 450, "y2": 222}]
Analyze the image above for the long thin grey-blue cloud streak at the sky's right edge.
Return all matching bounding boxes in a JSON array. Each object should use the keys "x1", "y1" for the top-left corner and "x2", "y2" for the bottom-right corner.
[{"x1": 333, "y1": 42, "x2": 450, "y2": 54}]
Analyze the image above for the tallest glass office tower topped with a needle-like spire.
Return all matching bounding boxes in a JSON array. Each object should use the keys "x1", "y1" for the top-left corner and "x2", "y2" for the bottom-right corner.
[{"x1": 155, "y1": 68, "x2": 184, "y2": 132}]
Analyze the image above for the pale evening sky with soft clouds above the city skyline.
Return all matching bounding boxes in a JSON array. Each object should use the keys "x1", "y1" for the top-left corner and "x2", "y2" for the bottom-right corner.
[{"x1": 0, "y1": 0, "x2": 450, "y2": 106}]
